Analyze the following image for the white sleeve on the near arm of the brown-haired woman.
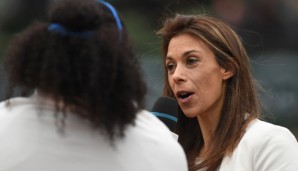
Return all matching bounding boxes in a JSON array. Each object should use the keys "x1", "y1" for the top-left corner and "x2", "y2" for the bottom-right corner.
[{"x1": 253, "y1": 127, "x2": 298, "y2": 171}]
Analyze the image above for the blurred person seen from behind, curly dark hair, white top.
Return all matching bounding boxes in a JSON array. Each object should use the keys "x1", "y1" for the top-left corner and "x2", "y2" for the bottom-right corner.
[{"x1": 0, "y1": 0, "x2": 187, "y2": 171}]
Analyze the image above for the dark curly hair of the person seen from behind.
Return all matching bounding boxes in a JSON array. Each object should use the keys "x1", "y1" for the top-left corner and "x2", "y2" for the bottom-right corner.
[{"x1": 5, "y1": 0, "x2": 146, "y2": 141}]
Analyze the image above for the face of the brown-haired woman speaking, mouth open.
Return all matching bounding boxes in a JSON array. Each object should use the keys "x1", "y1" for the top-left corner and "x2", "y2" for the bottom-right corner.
[{"x1": 166, "y1": 34, "x2": 232, "y2": 118}]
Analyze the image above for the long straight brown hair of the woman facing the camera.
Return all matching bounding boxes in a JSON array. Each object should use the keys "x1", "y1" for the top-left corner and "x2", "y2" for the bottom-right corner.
[{"x1": 158, "y1": 14, "x2": 259, "y2": 171}]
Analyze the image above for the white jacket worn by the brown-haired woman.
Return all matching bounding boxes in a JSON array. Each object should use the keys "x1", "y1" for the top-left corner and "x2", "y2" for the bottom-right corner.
[{"x1": 219, "y1": 119, "x2": 298, "y2": 171}]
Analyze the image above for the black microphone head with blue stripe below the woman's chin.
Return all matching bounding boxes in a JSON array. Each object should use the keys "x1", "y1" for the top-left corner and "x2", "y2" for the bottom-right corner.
[{"x1": 151, "y1": 96, "x2": 178, "y2": 131}]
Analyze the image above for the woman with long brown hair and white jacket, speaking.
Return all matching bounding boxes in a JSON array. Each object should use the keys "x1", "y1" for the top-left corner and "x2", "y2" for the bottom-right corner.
[{"x1": 158, "y1": 14, "x2": 298, "y2": 171}]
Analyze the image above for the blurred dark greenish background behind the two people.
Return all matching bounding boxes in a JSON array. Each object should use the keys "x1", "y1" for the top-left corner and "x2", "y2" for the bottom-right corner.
[{"x1": 0, "y1": 0, "x2": 298, "y2": 138}]
